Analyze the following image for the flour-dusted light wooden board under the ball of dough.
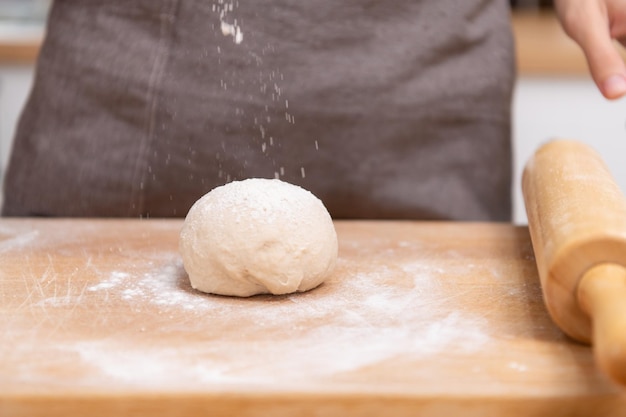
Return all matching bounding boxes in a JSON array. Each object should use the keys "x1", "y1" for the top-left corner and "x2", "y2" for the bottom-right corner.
[{"x1": 0, "y1": 219, "x2": 626, "y2": 416}]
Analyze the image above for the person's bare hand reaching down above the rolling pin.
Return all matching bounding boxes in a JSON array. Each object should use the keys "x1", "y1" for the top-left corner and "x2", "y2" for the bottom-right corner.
[{"x1": 554, "y1": 0, "x2": 626, "y2": 99}]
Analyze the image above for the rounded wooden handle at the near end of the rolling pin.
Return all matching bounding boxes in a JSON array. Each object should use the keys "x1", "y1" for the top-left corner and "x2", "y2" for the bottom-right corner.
[{"x1": 577, "y1": 263, "x2": 626, "y2": 384}]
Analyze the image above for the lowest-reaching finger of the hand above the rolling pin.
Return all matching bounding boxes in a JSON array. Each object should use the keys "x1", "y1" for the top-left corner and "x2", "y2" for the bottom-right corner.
[{"x1": 561, "y1": 2, "x2": 626, "y2": 99}]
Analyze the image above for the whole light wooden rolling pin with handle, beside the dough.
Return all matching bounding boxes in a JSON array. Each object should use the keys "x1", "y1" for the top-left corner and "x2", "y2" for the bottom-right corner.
[{"x1": 522, "y1": 140, "x2": 626, "y2": 384}]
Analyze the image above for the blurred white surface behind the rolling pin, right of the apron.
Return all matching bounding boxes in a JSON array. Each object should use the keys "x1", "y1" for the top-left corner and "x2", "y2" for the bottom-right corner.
[{"x1": 513, "y1": 77, "x2": 626, "y2": 224}]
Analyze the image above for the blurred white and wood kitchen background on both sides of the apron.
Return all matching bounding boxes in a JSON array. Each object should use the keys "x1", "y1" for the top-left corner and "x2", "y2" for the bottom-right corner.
[{"x1": 0, "y1": 0, "x2": 626, "y2": 224}]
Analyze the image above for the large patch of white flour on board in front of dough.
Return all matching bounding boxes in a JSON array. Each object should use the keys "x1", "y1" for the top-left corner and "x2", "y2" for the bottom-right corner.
[{"x1": 63, "y1": 256, "x2": 490, "y2": 386}]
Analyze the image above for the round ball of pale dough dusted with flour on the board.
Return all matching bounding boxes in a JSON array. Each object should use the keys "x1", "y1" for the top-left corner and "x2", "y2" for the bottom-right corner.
[{"x1": 180, "y1": 178, "x2": 337, "y2": 297}]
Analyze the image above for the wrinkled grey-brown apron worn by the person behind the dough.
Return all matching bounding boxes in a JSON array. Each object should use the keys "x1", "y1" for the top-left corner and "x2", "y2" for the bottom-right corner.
[{"x1": 3, "y1": 0, "x2": 514, "y2": 220}]
